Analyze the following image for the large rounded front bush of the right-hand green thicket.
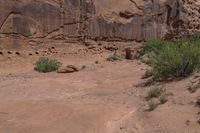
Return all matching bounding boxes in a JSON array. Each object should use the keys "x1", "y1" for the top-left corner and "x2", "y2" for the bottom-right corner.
[{"x1": 152, "y1": 43, "x2": 200, "y2": 78}]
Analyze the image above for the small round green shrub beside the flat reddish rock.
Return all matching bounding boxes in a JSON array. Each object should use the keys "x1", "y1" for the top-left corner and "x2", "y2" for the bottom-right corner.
[{"x1": 34, "y1": 57, "x2": 61, "y2": 73}]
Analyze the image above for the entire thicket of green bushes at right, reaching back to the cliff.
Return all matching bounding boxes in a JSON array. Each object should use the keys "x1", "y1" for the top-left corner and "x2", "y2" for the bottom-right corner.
[{"x1": 140, "y1": 35, "x2": 200, "y2": 79}]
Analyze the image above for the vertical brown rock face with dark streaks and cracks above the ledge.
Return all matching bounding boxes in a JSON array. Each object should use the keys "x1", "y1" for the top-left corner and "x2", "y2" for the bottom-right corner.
[{"x1": 0, "y1": 0, "x2": 200, "y2": 47}]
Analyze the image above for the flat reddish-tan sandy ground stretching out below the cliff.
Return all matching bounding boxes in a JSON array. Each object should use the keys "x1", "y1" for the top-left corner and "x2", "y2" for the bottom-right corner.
[{"x1": 0, "y1": 43, "x2": 200, "y2": 133}]
